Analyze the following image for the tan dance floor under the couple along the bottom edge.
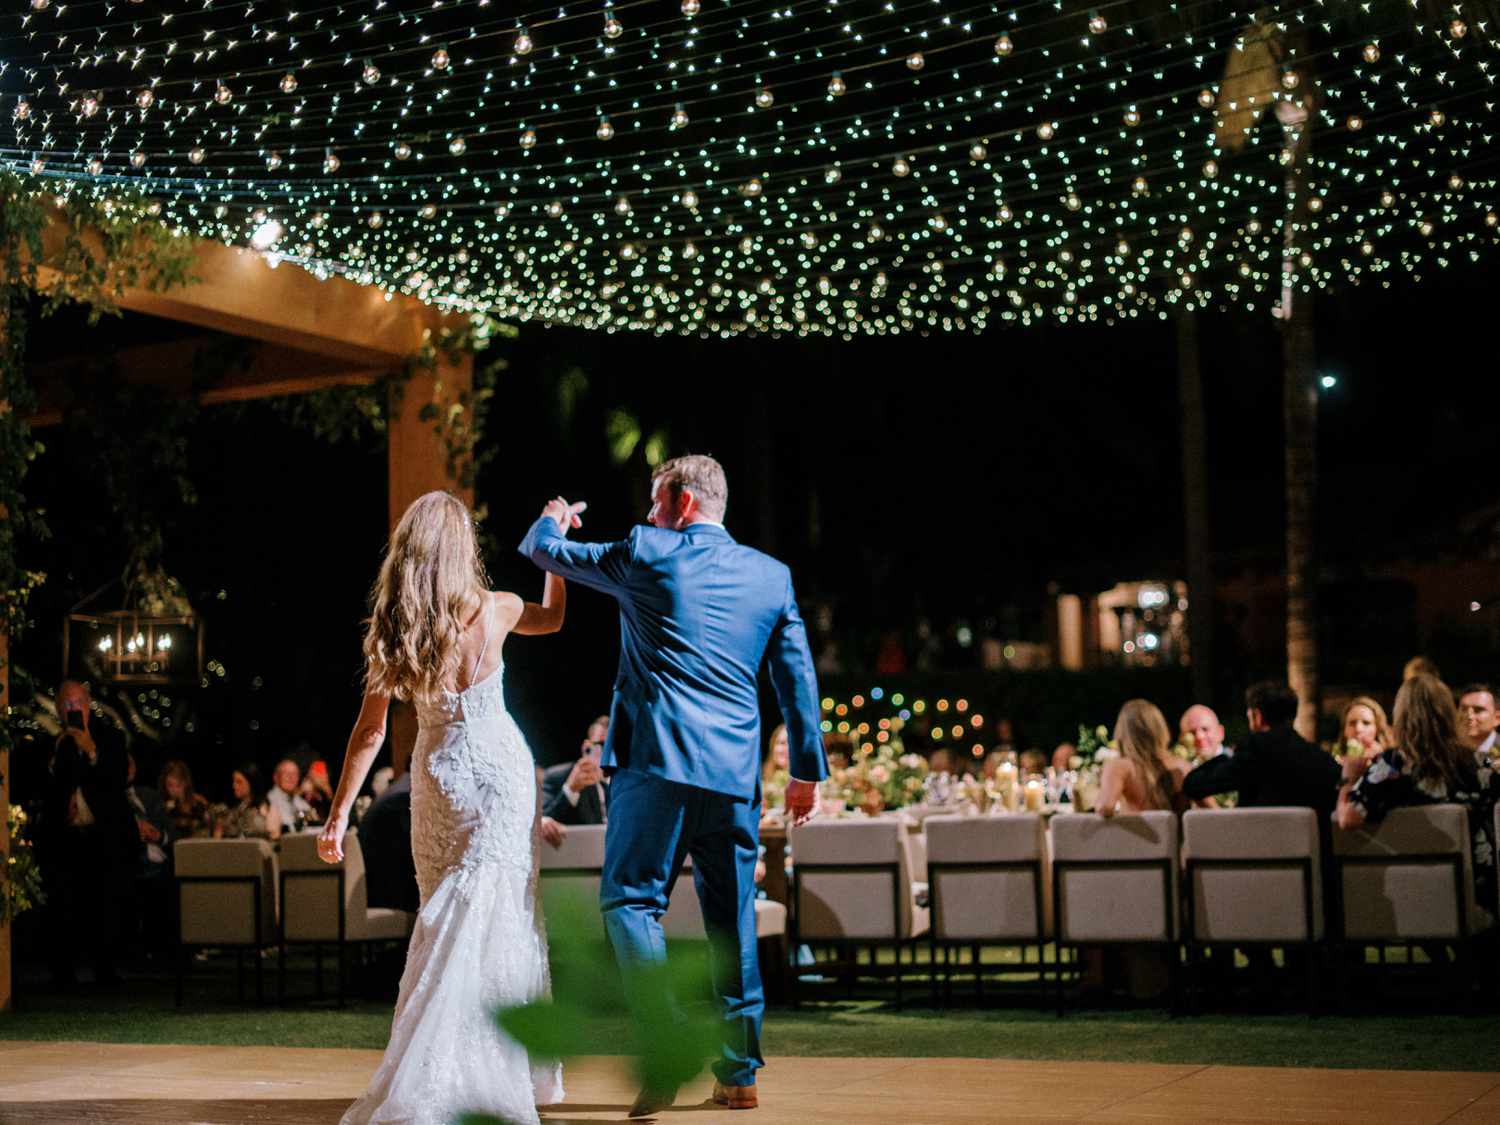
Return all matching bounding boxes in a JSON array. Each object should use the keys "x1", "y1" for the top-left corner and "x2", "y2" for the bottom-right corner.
[{"x1": 0, "y1": 1043, "x2": 1500, "y2": 1125}]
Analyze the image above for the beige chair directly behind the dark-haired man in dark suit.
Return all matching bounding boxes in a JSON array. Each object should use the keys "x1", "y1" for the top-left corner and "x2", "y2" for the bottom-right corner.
[{"x1": 1182, "y1": 809, "x2": 1323, "y2": 1004}]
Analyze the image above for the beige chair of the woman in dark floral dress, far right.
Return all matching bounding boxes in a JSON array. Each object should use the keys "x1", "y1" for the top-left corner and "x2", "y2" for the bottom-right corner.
[{"x1": 1334, "y1": 804, "x2": 1481, "y2": 992}]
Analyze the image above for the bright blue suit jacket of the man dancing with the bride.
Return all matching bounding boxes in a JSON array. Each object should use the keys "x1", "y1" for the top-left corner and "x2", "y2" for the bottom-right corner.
[{"x1": 521, "y1": 516, "x2": 828, "y2": 800}]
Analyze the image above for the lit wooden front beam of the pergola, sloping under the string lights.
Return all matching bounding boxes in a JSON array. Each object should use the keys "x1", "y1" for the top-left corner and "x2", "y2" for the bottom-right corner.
[{"x1": 41, "y1": 218, "x2": 462, "y2": 368}]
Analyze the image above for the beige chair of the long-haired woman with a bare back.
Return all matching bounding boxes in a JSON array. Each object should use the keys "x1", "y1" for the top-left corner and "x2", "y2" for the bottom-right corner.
[{"x1": 1049, "y1": 812, "x2": 1179, "y2": 1013}]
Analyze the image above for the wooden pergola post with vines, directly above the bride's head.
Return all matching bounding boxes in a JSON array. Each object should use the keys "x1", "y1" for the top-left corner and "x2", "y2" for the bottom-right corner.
[{"x1": 386, "y1": 354, "x2": 474, "y2": 528}]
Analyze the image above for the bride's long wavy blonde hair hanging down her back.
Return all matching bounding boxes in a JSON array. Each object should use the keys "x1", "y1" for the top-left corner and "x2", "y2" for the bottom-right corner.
[{"x1": 365, "y1": 492, "x2": 489, "y2": 701}]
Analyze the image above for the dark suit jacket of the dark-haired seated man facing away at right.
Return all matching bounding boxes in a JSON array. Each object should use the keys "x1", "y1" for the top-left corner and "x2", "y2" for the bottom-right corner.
[{"x1": 1182, "y1": 725, "x2": 1340, "y2": 831}]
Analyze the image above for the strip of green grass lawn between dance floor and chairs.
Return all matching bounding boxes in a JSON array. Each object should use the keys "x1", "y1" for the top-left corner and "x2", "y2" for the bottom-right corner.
[{"x1": 0, "y1": 972, "x2": 1500, "y2": 1070}]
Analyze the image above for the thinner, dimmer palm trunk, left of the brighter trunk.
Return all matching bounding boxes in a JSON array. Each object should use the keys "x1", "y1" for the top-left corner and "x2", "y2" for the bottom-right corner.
[{"x1": 1175, "y1": 305, "x2": 1214, "y2": 704}]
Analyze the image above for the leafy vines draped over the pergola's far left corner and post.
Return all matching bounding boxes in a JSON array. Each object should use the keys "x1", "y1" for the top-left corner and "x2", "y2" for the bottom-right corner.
[{"x1": 0, "y1": 173, "x2": 192, "y2": 759}]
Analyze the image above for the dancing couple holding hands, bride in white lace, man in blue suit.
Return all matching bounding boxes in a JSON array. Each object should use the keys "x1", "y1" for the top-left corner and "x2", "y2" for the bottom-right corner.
[{"x1": 320, "y1": 456, "x2": 827, "y2": 1124}]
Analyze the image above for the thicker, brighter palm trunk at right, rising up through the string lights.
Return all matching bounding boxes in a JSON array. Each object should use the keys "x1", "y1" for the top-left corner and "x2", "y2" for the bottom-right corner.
[{"x1": 1281, "y1": 114, "x2": 1319, "y2": 738}]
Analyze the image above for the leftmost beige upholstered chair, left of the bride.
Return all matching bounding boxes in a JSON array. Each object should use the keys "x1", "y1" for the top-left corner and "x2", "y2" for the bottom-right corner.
[{"x1": 173, "y1": 840, "x2": 278, "y2": 1004}]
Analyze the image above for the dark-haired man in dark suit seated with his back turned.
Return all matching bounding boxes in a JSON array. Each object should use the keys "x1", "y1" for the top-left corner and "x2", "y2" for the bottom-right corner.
[{"x1": 1182, "y1": 680, "x2": 1338, "y2": 825}]
